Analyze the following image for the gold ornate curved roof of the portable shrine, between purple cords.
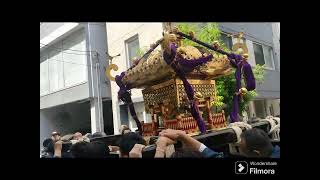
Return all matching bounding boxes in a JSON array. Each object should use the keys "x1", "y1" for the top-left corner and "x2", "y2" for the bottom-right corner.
[{"x1": 122, "y1": 46, "x2": 231, "y2": 88}]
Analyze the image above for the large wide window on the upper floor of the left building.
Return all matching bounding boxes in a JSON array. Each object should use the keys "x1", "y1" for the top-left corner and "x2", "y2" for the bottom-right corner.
[{"x1": 40, "y1": 29, "x2": 87, "y2": 96}]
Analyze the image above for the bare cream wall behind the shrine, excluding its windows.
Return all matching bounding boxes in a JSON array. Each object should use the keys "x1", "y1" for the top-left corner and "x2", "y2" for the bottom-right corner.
[{"x1": 107, "y1": 23, "x2": 163, "y2": 134}]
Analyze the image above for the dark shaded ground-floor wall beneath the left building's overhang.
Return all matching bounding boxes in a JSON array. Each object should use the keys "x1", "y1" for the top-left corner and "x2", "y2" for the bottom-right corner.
[{"x1": 40, "y1": 102, "x2": 90, "y2": 148}]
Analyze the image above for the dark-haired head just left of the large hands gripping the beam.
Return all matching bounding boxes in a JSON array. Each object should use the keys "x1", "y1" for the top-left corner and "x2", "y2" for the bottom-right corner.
[{"x1": 119, "y1": 132, "x2": 146, "y2": 157}]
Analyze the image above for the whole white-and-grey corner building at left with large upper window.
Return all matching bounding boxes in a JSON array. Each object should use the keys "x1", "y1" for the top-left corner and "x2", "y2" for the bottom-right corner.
[{"x1": 40, "y1": 23, "x2": 113, "y2": 147}]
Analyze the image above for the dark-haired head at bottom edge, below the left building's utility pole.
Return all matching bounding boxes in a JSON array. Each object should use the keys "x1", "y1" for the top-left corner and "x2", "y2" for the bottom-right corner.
[{"x1": 70, "y1": 141, "x2": 109, "y2": 158}]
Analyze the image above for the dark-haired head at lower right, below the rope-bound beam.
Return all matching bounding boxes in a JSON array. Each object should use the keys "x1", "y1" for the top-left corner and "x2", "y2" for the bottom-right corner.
[{"x1": 239, "y1": 128, "x2": 272, "y2": 157}]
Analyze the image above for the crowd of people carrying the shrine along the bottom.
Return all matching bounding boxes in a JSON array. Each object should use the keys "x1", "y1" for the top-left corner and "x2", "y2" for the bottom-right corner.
[{"x1": 40, "y1": 125, "x2": 280, "y2": 158}]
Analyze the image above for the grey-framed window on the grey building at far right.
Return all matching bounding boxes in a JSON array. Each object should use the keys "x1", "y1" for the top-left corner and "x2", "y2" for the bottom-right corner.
[{"x1": 253, "y1": 43, "x2": 274, "y2": 69}]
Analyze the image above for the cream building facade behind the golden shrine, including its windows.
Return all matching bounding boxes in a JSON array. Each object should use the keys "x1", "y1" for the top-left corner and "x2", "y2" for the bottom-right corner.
[{"x1": 107, "y1": 23, "x2": 163, "y2": 134}]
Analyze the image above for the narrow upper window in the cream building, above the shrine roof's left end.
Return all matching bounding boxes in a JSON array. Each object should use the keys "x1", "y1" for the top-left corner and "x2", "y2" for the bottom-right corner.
[{"x1": 125, "y1": 35, "x2": 140, "y2": 67}]
